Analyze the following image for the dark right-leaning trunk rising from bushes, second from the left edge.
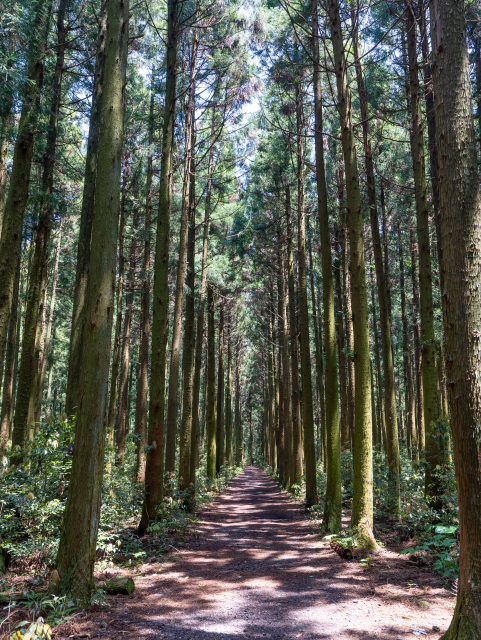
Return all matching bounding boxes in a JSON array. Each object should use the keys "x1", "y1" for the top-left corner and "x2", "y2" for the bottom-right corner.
[{"x1": 10, "y1": 0, "x2": 67, "y2": 464}]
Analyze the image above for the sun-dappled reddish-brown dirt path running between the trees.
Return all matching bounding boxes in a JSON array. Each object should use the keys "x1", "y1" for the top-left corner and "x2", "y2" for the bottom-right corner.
[{"x1": 54, "y1": 467, "x2": 454, "y2": 640}]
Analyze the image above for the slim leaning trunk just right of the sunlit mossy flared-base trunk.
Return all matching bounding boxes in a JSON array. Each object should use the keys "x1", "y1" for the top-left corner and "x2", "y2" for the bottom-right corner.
[{"x1": 351, "y1": 3, "x2": 401, "y2": 520}]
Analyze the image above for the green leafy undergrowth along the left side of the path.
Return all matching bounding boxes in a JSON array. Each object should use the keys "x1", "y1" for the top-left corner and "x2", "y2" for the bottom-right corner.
[{"x1": 0, "y1": 419, "x2": 242, "y2": 571}]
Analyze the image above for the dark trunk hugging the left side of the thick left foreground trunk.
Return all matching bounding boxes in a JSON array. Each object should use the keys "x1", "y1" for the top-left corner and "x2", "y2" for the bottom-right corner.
[{"x1": 65, "y1": 7, "x2": 107, "y2": 416}]
